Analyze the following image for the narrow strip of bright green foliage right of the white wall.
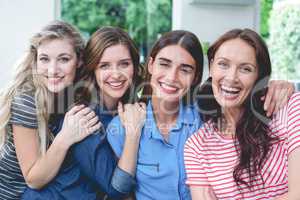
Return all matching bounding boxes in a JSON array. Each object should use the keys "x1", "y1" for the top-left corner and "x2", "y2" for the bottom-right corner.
[{"x1": 260, "y1": 0, "x2": 273, "y2": 38}]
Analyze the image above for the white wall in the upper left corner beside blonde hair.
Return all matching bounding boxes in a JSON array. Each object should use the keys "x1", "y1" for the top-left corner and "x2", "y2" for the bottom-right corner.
[{"x1": 0, "y1": 0, "x2": 60, "y2": 88}]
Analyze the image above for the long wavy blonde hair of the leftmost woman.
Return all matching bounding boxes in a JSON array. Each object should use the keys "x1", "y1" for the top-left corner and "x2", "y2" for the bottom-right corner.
[{"x1": 0, "y1": 21, "x2": 85, "y2": 154}]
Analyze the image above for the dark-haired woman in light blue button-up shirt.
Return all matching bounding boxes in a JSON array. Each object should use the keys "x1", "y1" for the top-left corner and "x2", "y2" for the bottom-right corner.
[{"x1": 107, "y1": 31, "x2": 203, "y2": 200}]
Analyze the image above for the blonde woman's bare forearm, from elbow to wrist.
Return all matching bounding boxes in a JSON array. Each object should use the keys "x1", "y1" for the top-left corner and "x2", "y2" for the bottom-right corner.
[{"x1": 25, "y1": 136, "x2": 69, "y2": 189}]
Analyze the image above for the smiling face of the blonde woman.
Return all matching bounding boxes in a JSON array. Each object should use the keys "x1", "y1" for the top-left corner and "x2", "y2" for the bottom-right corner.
[{"x1": 37, "y1": 39, "x2": 78, "y2": 93}]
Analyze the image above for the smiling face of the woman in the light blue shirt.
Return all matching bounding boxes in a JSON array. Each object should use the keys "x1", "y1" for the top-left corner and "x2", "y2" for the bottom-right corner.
[{"x1": 148, "y1": 45, "x2": 196, "y2": 102}]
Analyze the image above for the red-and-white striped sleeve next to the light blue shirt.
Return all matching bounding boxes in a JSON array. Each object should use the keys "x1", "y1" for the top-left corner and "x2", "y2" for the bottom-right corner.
[{"x1": 184, "y1": 133, "x2": 209, "y2": 186}]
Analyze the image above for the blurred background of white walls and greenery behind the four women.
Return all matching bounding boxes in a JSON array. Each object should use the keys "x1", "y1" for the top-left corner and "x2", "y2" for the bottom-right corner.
[{"x1": 0, "y1": 0, "x2": 300, "y2": 90}]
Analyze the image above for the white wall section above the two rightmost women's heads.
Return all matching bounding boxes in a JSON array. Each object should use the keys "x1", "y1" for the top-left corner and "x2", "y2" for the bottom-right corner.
[{"x1": 172, "y1": 0, "x2": 260, "y2": 81}]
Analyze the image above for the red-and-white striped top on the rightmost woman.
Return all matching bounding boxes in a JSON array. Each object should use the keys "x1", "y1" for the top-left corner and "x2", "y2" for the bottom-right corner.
[{"x1": 184, "y1": 93, "x2": 300, "y2": 200}]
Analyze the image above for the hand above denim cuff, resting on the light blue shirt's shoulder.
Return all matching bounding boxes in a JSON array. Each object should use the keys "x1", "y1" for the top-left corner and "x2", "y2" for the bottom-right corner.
[{"x1": 118, "y1": 102, "x2": 146, "y2": 137}]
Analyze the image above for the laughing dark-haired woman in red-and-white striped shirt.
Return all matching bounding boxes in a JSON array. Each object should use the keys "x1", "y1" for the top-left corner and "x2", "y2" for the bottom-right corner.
[{"x1": 184, "y1": 29, "x2": 300, "y2": 200}]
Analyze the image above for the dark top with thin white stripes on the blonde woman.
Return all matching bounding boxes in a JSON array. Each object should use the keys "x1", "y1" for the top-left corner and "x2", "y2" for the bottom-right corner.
[{"x1": 0, "y1": 93, "x2": 37, "y2": 200}]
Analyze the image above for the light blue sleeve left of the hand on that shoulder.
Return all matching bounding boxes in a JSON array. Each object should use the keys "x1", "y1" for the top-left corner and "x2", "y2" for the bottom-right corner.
[{"x1": 106, "y1": 116, "x2": 125, "y2": 158}]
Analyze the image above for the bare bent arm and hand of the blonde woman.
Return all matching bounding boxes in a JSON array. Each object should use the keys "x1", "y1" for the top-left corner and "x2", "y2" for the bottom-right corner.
[{"x1": 13, "y1": 106, "x2": 99, "y2": 189}]
